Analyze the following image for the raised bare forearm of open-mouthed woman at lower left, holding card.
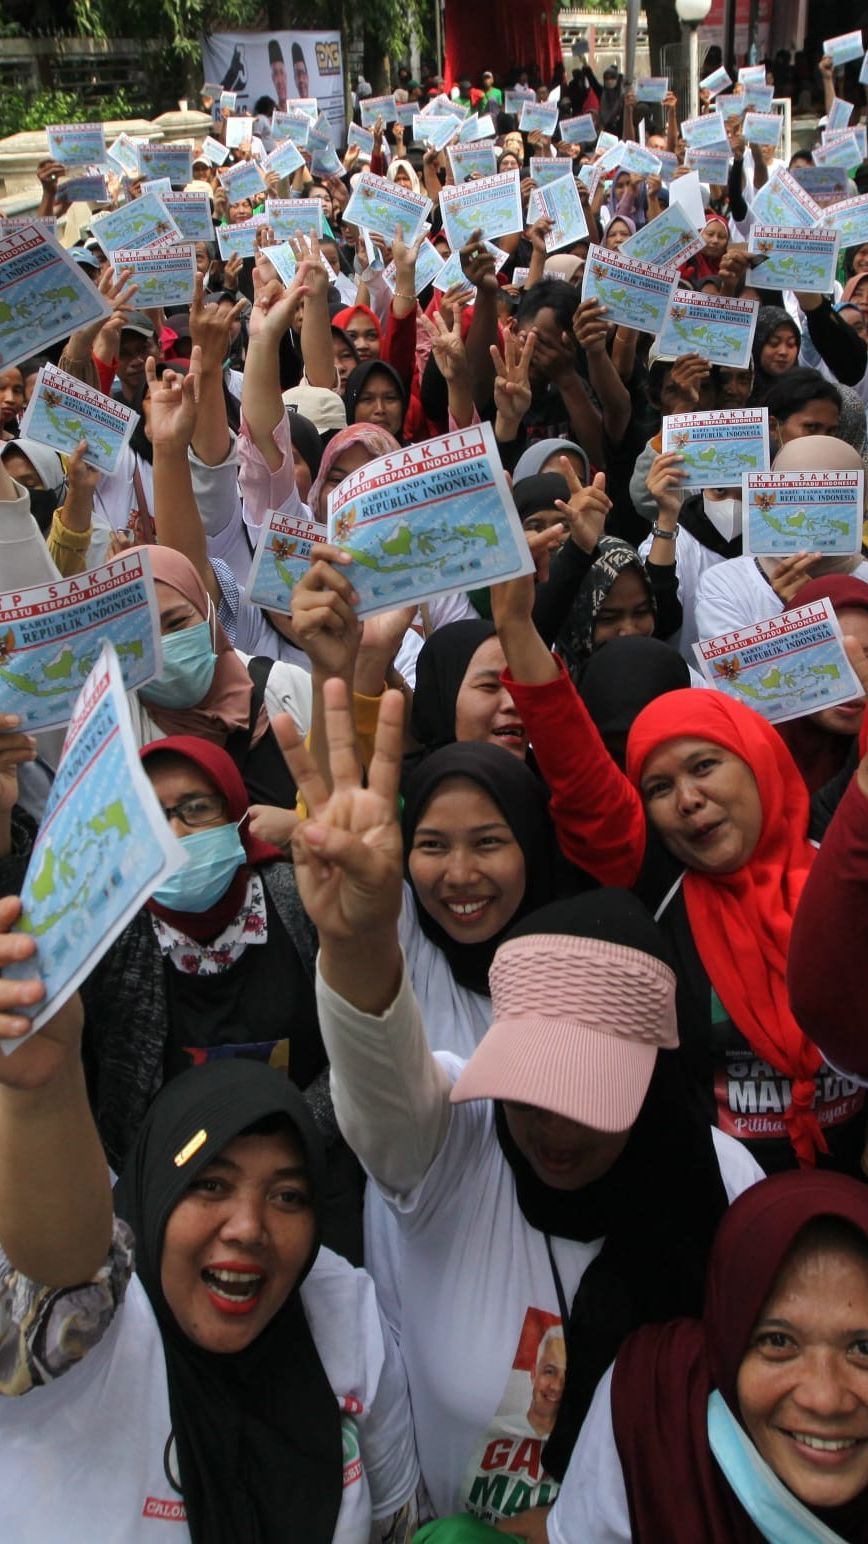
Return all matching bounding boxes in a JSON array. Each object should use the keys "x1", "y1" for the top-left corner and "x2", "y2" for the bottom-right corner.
[{"x1": 0, "y1": 896, "x2": 111, "y2": 1286}]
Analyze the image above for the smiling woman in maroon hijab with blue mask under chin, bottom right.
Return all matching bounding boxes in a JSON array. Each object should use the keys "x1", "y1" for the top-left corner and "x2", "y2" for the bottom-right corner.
[{"x1": 547, "y1": 1173, "x2": 868, "y2": 1544}]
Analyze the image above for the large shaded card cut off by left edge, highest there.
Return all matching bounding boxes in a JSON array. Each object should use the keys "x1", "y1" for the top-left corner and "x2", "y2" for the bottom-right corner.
[{"x1": 0, "y1": 221, "x2": 111, "y2": 365}]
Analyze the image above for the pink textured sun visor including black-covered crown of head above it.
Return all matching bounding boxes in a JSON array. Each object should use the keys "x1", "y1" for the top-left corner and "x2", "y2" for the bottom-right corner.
[{"x1": 451, "y1": 889, "x2": 678, "y2": 1132}]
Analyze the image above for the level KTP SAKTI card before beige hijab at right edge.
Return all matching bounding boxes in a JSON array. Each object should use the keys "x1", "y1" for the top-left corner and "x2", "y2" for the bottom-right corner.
[{"x1": 741, "y1": 471, "x2": 865, "y2": 557}]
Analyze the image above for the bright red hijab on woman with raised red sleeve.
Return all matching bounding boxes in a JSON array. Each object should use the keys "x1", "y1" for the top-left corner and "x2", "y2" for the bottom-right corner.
[{"x1": 627, "y1": 687, "x2": 826, "y2": 1164}]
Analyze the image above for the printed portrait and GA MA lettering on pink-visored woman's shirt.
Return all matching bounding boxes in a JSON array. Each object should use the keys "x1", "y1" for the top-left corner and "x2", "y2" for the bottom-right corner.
[{"x1": 465, "y1": 1308, "x2": 567, "y2": 1522}]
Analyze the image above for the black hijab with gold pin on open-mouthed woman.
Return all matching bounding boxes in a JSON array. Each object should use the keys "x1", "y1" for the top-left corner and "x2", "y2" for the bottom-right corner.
[{"x1": 114, "y1": 1059, "x2": 343, "y2": 1544}]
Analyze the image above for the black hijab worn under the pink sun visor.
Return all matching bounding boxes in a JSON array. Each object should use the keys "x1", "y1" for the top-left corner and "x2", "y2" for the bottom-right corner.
[{"x1": 494, "y1": 901, "x2": 727, "y2": 1479}]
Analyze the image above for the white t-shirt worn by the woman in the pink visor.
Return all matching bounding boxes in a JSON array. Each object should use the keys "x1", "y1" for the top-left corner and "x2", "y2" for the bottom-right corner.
[{"x1": 368, "y1": 1053, "x2": 763, "y2": 1522}]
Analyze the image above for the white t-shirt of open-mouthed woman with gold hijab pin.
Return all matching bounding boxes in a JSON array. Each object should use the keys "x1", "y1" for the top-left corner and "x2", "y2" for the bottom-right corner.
[{"x1": 0, "y1": 1249, "x2": 419, "y2": 1544}]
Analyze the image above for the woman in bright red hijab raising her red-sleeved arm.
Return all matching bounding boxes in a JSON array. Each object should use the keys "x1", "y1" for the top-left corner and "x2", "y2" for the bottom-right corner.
[{"x1": 493, "y1": 581, "x2": 865, "y2": 1173}]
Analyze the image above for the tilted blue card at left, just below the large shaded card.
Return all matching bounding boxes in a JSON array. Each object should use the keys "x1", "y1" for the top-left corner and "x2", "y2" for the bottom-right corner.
[{"x1": 20, "y1": 364, "x2": 139, "y2": 474}]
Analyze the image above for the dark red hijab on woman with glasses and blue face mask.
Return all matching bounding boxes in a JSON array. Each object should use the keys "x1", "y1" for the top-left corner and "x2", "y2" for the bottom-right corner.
[{"x1": 139, "y1": 735, "x2": 286, "y2": 939}]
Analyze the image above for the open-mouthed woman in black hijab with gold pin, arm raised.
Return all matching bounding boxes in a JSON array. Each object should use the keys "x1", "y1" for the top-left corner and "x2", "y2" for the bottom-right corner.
[{"x1": 0, "y1": 963, "x2": 417, "y2": 1544}]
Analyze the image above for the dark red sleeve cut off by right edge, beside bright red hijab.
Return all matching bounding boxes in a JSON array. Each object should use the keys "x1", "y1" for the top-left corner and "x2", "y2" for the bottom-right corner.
[{"x1": 788, "y1": 777, "x2": 868, "y2": 1079}]
